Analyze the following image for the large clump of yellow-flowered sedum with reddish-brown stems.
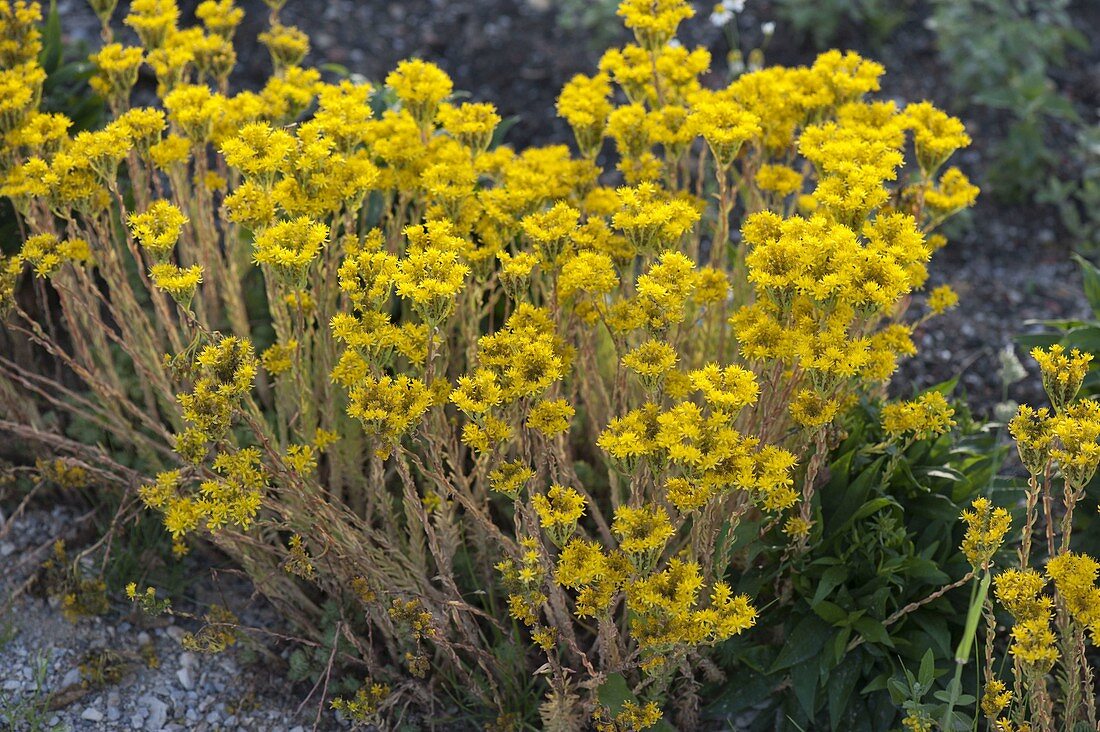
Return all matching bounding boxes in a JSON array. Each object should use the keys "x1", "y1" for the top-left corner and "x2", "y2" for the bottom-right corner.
[{"x1": 0, "y1": 0, "x2": 977, "y2": 730}]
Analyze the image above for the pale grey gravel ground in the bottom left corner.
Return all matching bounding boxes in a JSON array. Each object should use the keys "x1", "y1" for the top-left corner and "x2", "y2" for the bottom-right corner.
[{"x1": 0, "y1": 506, "x2": 338, "y2": 732}]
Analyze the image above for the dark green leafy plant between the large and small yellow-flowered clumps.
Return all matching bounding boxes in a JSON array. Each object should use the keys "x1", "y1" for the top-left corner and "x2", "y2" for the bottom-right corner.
[{"x1": 708, "y1": 394, "x2": 1014, "y2": 731}]
